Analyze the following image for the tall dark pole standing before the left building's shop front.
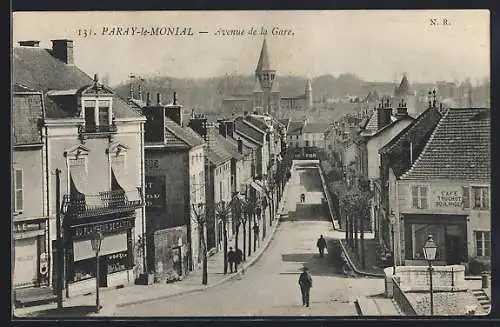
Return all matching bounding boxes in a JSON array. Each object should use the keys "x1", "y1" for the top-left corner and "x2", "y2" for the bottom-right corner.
[{"x1": 56, "y1": 168, "x2": 65, "y2": 308}]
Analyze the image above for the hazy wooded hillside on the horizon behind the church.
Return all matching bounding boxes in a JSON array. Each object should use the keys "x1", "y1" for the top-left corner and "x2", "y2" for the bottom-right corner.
[{"x1": 114, "y1": 74, "x2": 486, "y2": 114}]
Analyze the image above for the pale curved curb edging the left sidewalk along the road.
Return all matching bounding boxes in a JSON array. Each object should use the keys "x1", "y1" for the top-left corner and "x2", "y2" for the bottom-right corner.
[{"x1": 115, "y1": 218, "x2": 280, "y2": 308}]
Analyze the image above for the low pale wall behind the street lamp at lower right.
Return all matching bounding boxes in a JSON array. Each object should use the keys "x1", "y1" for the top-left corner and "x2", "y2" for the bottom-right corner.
[{"x1": 394, "y1": 265, "x2": 467, "y2": 292}]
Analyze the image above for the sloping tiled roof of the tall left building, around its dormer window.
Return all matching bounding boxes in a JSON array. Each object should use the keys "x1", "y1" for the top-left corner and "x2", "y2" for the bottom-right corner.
[{"x1": 12, "y1": 47, "x2": 142, "y2": 118}]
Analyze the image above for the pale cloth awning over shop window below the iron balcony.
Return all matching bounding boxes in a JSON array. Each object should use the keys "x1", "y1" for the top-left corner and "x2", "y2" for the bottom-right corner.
[{"x1": 73, "y1": 232, "x2": 127, "y2": 261}]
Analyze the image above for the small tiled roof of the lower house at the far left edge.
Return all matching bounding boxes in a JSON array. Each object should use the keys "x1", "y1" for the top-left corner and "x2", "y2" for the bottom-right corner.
[{"x1": 12, "y1": 93, "x2": 42, "y2": 145}]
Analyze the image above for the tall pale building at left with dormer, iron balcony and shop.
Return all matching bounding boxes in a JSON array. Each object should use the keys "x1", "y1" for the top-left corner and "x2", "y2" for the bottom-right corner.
[{"x1": 13, "y1": 40, "x2": 147, "y2": 296}]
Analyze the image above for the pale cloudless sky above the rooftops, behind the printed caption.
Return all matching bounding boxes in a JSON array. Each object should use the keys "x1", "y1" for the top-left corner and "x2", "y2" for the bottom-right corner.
[{"x1": 12, "y1": 10, "x2": 490, "y2": 85}]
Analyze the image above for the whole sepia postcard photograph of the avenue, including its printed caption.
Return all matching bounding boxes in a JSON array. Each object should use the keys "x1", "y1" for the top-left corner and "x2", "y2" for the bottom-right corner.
[{"x1": 10, "y1": 10, "x2": 492, "y2": 321}]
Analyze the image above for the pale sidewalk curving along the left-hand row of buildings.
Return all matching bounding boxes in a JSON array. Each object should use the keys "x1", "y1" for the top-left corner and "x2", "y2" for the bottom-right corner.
[{"x1": 14, "y1": 183, "x2": 288, "y2": 317}]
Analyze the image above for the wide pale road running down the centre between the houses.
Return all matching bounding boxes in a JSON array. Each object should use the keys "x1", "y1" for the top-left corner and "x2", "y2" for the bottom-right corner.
[{"x1": 116, "y1": 169, "x2": 384, "y2": 316}]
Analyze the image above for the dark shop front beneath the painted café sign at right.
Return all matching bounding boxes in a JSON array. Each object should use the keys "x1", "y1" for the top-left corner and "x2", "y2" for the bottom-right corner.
[{"x1": 402, "y1": 214, "x2": 468, "y2": 265}]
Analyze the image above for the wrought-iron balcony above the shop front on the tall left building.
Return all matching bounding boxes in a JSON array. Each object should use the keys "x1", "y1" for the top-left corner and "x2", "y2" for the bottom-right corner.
[{"x1": 62, "y1": 187, "x2": 144, "y2": 218}]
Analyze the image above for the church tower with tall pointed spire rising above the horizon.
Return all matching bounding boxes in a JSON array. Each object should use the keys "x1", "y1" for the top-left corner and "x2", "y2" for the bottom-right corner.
[{"x1": 254, "y1": 39, "x2": 277, "y2": 114}]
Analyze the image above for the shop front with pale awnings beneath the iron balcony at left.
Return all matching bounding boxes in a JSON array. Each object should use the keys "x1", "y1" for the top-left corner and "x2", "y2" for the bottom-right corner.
[{"x1": 66, "y1": 215, "x2": 136, "y2": 296}]
